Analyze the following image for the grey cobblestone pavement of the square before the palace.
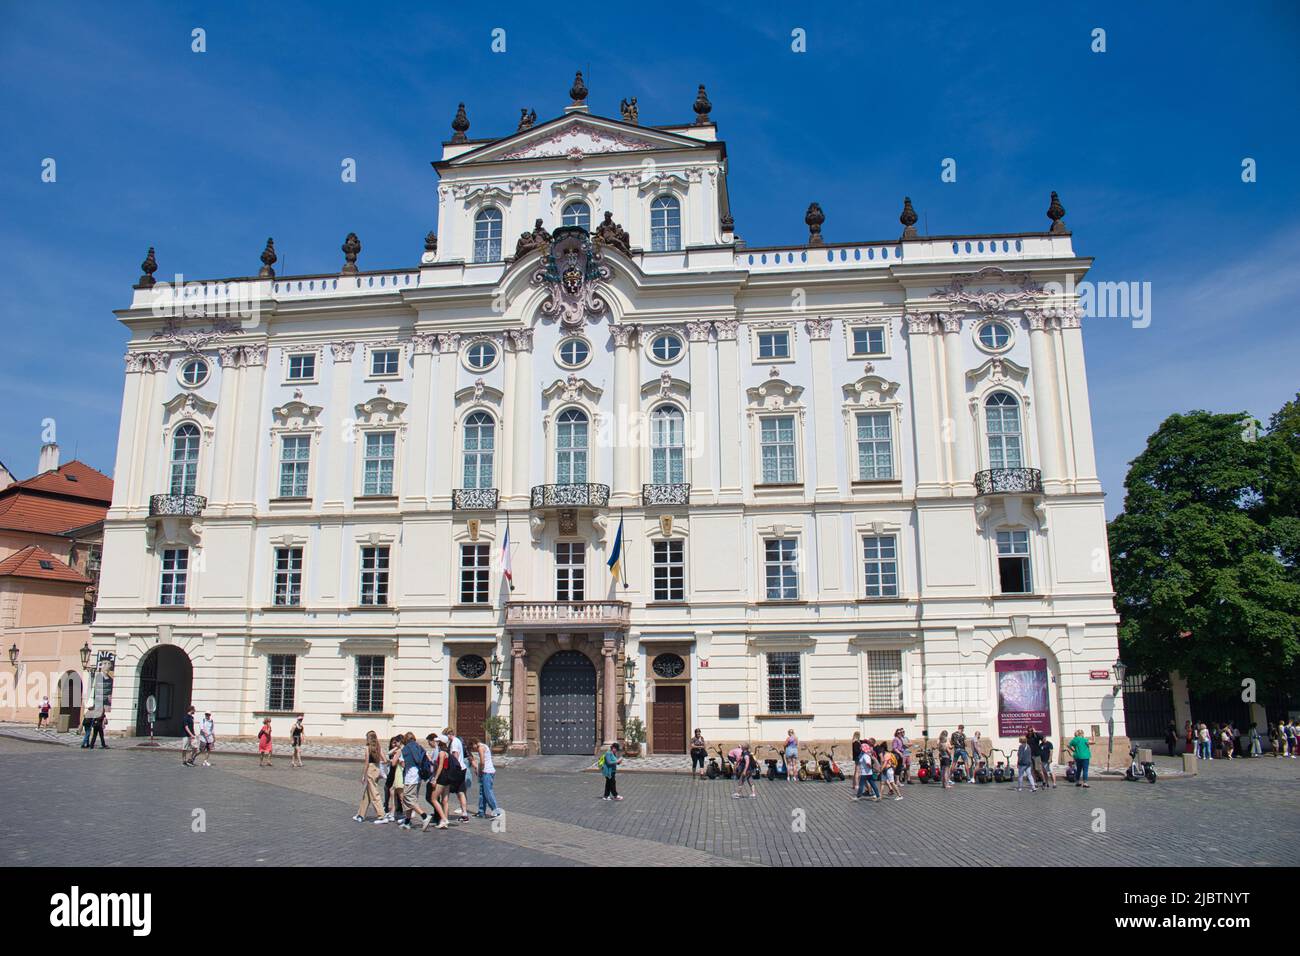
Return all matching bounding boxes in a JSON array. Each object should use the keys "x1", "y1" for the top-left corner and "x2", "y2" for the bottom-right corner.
[{"x1": 0, "y1": 736, "x2": 1300, "y2": 866}]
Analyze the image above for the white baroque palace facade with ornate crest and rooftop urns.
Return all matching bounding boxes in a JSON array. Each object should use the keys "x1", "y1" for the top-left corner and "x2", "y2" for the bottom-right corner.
[{"x1": 94, "y1": 77, "x2": 1125, "y2": 753}]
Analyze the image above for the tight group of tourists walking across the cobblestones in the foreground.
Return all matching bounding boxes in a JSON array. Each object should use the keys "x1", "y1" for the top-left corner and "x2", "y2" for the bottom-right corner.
[{"x1": 352, "y1": 727, "x2": 502, "y2": 830}]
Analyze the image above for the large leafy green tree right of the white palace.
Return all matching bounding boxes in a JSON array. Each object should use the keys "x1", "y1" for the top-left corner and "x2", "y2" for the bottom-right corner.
[{"x1": 1110, "y1": 403, "x2": 1300, "y2": 691}]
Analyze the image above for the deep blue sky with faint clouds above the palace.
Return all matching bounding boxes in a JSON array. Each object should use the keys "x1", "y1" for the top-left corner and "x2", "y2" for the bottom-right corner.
[{"x1": 0, "y1": 0, "x2": 1300, "y2": 514}]
